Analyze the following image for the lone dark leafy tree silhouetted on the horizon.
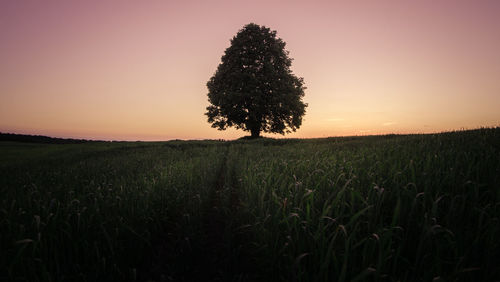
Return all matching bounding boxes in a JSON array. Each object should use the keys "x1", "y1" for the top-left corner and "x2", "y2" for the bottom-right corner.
[{"x1": 206, "y1": 23, "x2": 307, "y2": 138}]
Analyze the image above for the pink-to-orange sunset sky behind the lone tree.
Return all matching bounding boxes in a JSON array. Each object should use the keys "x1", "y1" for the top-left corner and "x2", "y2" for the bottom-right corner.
[{"x1": 0, "y1": 0, "x2": 500, "y2": 141}]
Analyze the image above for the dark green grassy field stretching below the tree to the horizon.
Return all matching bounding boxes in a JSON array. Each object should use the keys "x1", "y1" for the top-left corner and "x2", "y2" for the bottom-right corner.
[{"x1": 0, "y1": 128, "x2": 500, "y2": 281}]
